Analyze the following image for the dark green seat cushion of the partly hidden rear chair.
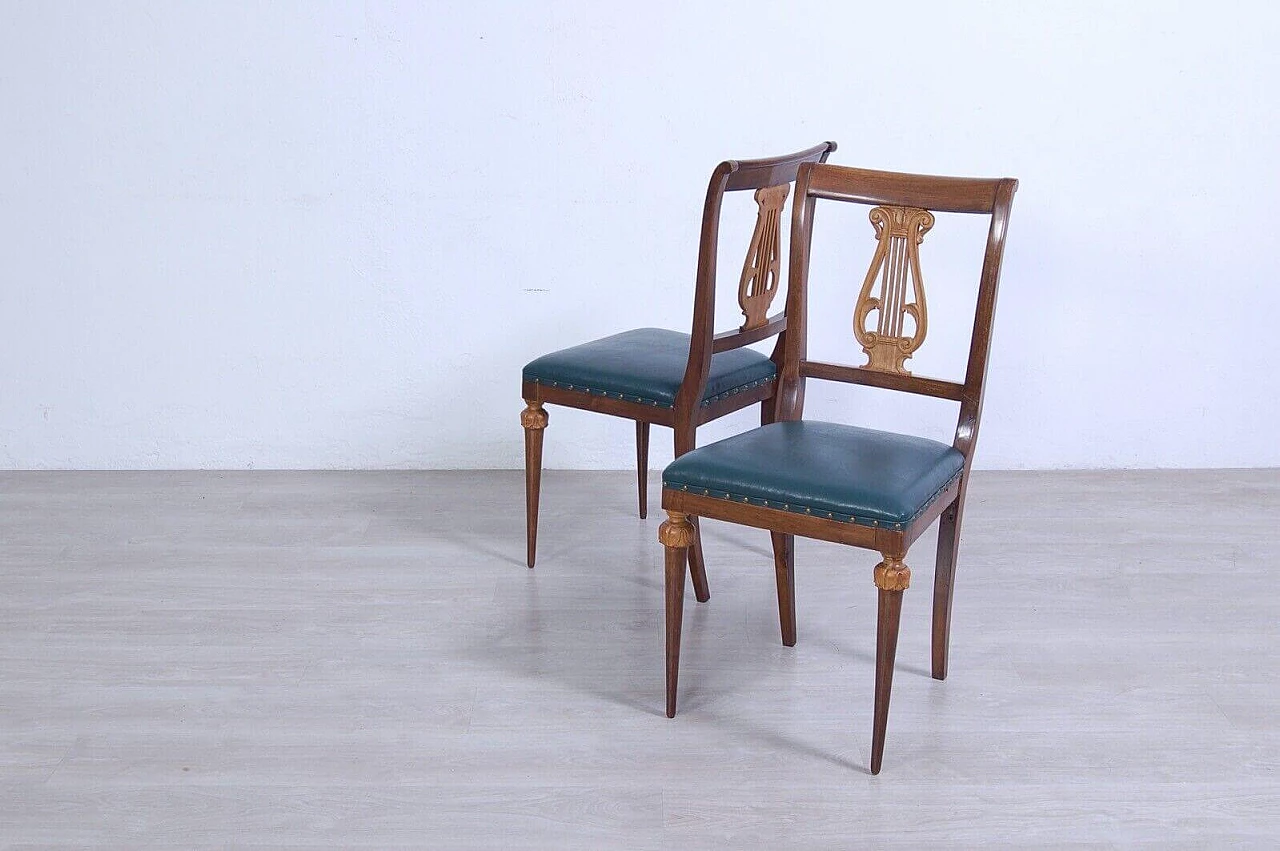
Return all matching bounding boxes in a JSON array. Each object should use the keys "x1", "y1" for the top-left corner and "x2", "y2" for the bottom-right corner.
[{"x1": 525, "y1": 328, "x2": 776, "y2": 408}]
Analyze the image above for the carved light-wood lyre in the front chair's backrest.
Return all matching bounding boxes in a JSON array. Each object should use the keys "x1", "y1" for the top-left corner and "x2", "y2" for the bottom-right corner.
[{"x1": 854, "y1": 207, "x2": 933, "y2": 375}]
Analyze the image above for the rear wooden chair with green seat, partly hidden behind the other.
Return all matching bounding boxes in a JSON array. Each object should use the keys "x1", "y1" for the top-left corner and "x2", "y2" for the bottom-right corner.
[{"x1": 520, "y1": 142, "x2": 836, "y2": 601}]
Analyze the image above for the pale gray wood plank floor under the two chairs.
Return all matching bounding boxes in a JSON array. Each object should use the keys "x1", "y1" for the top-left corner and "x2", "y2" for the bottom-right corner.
[{"x1": 0, "y1": 471, "x2": 1280, "y2": 848}]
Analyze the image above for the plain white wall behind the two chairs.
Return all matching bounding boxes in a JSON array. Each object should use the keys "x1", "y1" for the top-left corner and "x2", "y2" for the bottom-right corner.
[{"x1": 0, "y1": 1, "x2": 1280, "y2": 468}]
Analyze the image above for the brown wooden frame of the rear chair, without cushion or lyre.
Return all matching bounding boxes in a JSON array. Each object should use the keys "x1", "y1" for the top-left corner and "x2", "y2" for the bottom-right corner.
[{"x1": 521, "y1": 142, "x2": 836, "y2": 601}]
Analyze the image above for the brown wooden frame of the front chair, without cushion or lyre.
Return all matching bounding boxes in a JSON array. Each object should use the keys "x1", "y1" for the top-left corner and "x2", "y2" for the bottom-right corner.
[{"x1": 658, "y1": 157, "x2": 1018, "y2": 774}]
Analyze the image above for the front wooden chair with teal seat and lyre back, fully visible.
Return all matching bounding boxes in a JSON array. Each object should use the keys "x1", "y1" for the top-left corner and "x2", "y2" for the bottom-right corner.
[{"x1": 658, "y1": 165, "x2": 1018, "y2": 774}]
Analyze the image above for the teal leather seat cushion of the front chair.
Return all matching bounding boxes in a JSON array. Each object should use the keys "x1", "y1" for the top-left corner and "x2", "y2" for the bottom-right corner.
[{"x1": 662, "y1": 421, "x2": 964, "y2": 530}]
